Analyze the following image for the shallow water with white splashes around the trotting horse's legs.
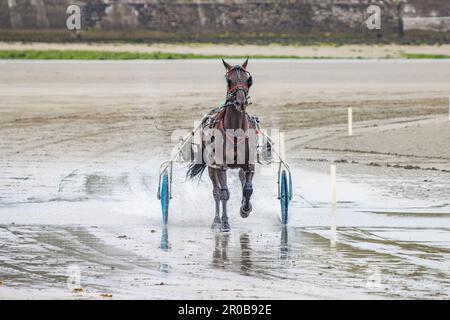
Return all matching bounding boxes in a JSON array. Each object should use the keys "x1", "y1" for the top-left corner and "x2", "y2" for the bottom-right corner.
[{"x1": 0, "y1": 162, "x2": 450, "y2": 299}]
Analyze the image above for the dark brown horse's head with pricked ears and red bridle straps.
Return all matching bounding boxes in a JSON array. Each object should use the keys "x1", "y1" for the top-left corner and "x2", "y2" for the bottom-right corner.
[{"x1": 222, "y1": 59, "x2": 253, "y2": 112}]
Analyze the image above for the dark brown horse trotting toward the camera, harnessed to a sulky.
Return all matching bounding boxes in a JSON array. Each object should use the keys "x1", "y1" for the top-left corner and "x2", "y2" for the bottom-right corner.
[{"x1": 187, "y1": 59, "x2": 257, "y2": 232}]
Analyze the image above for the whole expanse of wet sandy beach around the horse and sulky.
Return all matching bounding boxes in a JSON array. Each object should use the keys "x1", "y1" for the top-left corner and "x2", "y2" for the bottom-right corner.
[{"x1": 0, "y1": 60, "x2": 450, "y2": 299}]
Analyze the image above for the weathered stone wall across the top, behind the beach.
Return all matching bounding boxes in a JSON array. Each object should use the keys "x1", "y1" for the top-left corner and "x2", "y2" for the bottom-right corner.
[{"x1": 0, "y1": 0, "x2": 450, "y2": 35}]
